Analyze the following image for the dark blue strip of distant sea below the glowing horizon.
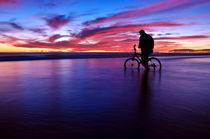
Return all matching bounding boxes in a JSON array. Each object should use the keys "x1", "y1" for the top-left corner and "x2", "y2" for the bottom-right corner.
[{"x1": 0, "y1": 52, "x2": 210, "y2": 61}]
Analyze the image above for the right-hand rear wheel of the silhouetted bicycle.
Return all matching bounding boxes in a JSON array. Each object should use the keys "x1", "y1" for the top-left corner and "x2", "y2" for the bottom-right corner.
[{"x1": 148, "y1": 57, "x2": 162, "y2": 71}]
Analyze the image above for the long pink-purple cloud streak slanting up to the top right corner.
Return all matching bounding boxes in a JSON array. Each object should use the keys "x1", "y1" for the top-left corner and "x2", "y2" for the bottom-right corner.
[{"x1": 83, "y1": 0, "x2": 210, "y2": 26}]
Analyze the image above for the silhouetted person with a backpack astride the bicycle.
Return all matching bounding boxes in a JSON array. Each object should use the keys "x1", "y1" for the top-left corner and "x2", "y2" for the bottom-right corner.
[{"x1": 139, "y1": 30, "x2": 154, "y2": 68}]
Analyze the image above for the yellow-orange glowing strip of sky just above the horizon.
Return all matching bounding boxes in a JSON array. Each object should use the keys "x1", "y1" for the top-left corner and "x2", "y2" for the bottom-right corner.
[{"x1": 0, "y1": 43, "x2": 210, "y2": 53}]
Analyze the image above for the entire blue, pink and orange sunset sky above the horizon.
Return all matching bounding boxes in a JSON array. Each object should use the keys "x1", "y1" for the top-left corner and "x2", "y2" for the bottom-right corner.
[{"x1": 0, "y1": 0, "x2": 210, "y2": 52}]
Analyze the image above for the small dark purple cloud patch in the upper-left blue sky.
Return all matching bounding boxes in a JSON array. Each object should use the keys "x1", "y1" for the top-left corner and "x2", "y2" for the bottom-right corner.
[{"x1": 43, "y1": 15, "x2": 72, "y2": 29}]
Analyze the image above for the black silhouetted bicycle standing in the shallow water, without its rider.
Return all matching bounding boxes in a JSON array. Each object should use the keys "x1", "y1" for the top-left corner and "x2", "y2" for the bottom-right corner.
[{"x1": 124, "y1": 45, "x2": 161, "y2": 71}]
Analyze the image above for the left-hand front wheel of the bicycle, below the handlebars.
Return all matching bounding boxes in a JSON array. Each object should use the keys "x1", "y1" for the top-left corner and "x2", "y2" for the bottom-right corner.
[{"x1": 124, "y1": 58, "x2": 140, "y2": 69}]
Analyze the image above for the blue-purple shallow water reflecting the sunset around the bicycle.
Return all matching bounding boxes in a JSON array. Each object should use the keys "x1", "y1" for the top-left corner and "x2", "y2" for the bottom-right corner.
[{"x1": 0, "y1": 57, "x2": 210, "y2": 138}]
